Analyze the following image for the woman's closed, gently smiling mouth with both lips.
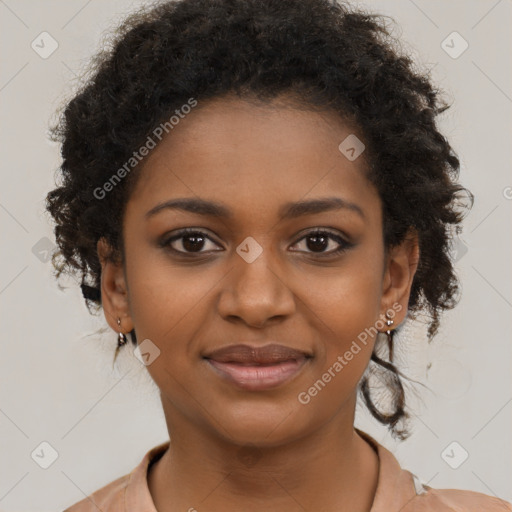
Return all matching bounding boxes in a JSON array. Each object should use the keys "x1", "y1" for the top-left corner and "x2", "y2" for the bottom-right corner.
[{"x1": 203, "y1": 344, "x2": 312, "y2": 391}]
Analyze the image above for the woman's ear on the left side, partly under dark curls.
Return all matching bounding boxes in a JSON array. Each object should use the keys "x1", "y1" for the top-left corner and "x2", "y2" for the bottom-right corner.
[{"x1": 96, "y1": 238, "x2": 133, "y2": 333}]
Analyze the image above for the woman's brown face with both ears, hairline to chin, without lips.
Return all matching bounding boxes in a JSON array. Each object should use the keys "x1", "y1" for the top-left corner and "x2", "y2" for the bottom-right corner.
[{"x1": 98, "y1": 98, "x2": 417, "y2": 446}]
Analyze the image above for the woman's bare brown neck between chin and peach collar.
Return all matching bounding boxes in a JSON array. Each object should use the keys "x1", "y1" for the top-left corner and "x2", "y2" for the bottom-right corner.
[{"x1": 148, "y1": 398, "x2": 378, "y2": 512}]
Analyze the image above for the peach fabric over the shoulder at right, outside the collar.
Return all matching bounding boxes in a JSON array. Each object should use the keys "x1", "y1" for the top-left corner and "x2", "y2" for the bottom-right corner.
[{"x1": 402, "y1": 478, "x2": 512, "y2": 512}]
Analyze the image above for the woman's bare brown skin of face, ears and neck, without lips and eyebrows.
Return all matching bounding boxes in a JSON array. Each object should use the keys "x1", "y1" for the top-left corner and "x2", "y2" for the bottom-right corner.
[{"x1": 98, "y1": 97, "x2": 418, "y2": 512}]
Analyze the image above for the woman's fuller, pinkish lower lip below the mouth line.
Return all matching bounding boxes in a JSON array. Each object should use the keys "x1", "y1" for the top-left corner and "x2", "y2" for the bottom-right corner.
[{"x1": 206, "y1": 358, "x2": 307, "y2": 391}]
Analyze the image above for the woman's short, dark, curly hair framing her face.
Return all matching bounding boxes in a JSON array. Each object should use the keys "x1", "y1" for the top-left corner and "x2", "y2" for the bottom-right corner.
[{"x1": 46, "y1": 0, "x2": 473, "y2": 439}]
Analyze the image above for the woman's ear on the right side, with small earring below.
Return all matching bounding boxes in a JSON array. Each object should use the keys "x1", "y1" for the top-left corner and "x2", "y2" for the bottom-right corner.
[{"x1": 381, "y1": 228, "x2": 420, "y2": 327}]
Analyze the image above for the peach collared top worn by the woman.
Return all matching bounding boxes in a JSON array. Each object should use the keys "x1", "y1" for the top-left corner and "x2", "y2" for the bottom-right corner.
[{"x1": 63, "y1": 429, "x2": 512, "y2": 512}]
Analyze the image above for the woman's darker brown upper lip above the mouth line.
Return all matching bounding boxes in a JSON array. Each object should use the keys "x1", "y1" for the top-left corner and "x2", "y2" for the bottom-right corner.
[{"x1": 204, "y1": 343, "x2": 312, "y2": 364}]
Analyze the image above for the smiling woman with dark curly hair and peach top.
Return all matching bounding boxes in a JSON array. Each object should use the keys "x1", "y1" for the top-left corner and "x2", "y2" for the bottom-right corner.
[{"x1": 47, "y1": 0, "x2": 512, "y2": 512}]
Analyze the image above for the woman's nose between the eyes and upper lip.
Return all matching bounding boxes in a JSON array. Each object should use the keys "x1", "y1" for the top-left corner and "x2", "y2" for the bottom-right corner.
[{"x1": 218, "y1": 250, "x2": 296, "y2": 328}]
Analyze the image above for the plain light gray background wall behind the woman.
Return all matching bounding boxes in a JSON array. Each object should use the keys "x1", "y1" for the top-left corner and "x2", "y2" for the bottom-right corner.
[{"x1": 0, "y1": 0, "x2": 512, "y2": 512}]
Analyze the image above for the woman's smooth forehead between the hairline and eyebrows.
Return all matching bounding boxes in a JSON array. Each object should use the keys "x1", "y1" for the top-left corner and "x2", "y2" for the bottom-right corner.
[{"x1": 124, "y1": 98, "x2": 379, "y2": 228}]
